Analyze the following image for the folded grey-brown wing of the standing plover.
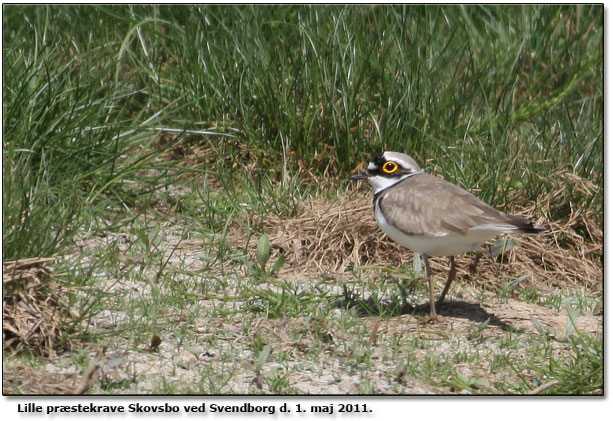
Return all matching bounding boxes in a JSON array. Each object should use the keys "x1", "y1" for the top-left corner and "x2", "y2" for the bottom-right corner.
[{"x1": 379, "y1": 174, "x2": 532, "y2": 236}]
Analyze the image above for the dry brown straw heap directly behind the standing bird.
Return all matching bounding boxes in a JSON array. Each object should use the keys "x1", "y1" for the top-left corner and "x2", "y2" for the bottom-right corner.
[{"x1": 239, "y1": 169, "x2": 603, "y2": 291}]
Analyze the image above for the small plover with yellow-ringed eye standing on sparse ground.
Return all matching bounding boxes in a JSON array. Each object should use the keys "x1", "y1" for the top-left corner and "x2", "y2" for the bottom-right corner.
[{"x1": 349, "y1": 151, "x2": 545, "y2": 321}]
